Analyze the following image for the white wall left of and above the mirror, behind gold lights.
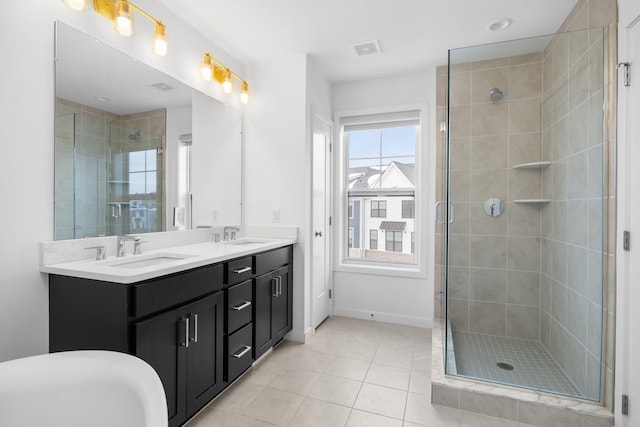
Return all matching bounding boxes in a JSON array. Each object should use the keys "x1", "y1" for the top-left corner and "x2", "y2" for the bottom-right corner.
[{"x1": 0, "y1": 0, "x2": 244, "y2": 361}]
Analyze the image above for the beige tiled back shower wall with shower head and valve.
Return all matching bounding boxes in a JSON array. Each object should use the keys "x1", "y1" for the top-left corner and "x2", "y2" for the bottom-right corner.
[{"x1": 436, "y1": 54, "x2": 542, "y2": 339}]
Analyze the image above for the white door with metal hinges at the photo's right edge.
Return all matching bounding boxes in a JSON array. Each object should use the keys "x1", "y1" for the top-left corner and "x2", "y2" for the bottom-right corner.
[{"x1": 615, "y1": 16, "x2": 640, "y2": 426}]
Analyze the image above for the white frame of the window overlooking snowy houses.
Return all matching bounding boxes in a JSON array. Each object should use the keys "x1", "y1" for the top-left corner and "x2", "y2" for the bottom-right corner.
[{"x1": 334, "y1": 104, "x2": 428, "y2": 278}]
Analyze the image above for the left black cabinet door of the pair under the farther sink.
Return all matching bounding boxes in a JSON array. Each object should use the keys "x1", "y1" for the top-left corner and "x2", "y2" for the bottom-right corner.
[{"x1": 253, "y1": 273, "x2": 275, "y2": 360}]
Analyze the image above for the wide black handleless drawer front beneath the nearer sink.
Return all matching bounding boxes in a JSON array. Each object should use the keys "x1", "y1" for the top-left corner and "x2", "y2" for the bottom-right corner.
[{"x1": 133, "y1": 264, "x2": 223, "y2": 317}]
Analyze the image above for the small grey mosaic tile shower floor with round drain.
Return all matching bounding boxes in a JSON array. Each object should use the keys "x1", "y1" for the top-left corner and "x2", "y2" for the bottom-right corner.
[{"x1": 453, "y1": 330, "x2": 583, "y2": 397}]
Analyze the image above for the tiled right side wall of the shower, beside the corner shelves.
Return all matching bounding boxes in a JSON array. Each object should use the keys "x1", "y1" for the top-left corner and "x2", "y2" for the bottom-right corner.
[{"x1": 540, "y1": 0, "x2": 616, "y2": 407}]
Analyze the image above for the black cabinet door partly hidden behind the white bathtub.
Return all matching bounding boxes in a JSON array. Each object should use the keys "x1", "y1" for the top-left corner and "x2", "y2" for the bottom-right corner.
[{"x1": 135, "y1": 310, "x2": 189, "y2": 426}]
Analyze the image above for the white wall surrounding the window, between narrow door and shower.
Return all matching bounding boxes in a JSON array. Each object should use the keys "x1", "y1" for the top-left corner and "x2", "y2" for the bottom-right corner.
[{"x1": 332, "y1": 70, "x2": 436, "y2": 327}]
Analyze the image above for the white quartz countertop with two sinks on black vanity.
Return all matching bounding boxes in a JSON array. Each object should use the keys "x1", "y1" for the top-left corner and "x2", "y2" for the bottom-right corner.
[{"x1": 40, "y1": 237, "x2": 297, "y2": 284}]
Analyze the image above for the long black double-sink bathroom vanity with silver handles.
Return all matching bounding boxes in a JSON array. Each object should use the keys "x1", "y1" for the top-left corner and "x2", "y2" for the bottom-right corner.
[{"x1": 46, "y1": 241, "x2": 293, "y2": 426}]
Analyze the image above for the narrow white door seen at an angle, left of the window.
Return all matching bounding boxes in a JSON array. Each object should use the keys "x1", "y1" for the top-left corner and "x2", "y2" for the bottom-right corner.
[{"x1": 311, "y1": 114, "x2": 332, "y2": 328}]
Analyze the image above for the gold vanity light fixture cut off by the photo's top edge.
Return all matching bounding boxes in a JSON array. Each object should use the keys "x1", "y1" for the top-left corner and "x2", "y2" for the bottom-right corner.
[{"x1": 64, "y1": 0, "x2": 167, "y2": 56}]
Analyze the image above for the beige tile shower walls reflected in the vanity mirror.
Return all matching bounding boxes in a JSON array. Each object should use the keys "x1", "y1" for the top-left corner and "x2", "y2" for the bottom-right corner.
[{"x1": 55, "y1": 98, "x2": 166, "y2": 240}]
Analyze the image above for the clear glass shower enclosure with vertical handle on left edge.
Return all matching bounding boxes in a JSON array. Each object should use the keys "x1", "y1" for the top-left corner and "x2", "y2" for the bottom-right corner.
[{"x1": 438, "y1": 30, "x2": 608, "y2": 402}]
